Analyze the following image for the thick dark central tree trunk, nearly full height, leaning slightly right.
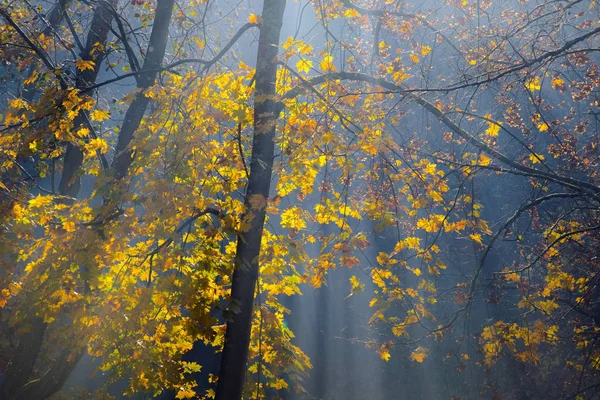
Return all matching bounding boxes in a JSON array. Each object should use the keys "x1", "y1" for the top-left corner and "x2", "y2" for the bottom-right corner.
[{"x1": 216, "y1": 0, "x2": 285, "y2": 400}]
